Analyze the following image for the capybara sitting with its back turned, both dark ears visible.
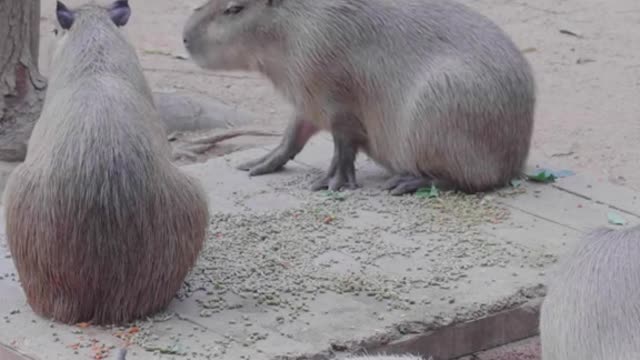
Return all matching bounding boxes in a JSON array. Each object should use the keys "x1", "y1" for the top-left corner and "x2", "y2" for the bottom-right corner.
[{"x1": 4, "y1": 0, "x2": 208, "y2": 325}]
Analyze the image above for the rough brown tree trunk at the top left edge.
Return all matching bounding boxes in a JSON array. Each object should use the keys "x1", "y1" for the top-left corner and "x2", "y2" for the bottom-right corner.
[{"x1": 0, "y1": 0, "x2": 46, "y2": 161}]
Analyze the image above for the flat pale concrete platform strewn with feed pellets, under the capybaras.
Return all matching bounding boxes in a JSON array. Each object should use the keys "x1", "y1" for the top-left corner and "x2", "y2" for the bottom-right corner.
[{"x1": 0, "y1": 136, "x2": 640, "y2": 360}]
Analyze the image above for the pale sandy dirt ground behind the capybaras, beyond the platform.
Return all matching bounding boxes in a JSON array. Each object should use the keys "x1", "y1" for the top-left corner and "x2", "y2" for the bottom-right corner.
[{"x1": 41, "y1": 0, "x2": 640, "y2": 189}]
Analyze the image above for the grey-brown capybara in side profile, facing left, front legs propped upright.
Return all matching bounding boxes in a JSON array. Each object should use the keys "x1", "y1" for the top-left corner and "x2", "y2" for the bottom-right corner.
[{"x1": 184, "y1": 0, "x2": 536, "y2": 195}]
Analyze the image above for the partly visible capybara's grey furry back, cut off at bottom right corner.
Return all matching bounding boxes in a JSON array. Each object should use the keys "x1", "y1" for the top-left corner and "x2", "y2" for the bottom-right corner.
[{"x1": 540, "y1": 226, "x2": 640, "y2": 360}]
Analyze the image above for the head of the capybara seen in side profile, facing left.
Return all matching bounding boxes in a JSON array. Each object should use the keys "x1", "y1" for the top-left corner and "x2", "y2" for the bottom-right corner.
[{"x1": 183, "y1": 0, "x2": 282, "y2": 70}]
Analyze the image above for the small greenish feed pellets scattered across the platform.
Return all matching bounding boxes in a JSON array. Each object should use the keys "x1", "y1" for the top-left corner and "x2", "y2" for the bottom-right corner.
[{"x1": 116, "y1": 175, "x2": 554, "y2": 358}]
